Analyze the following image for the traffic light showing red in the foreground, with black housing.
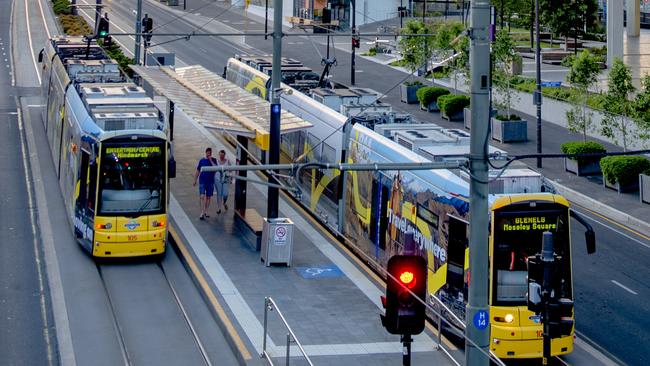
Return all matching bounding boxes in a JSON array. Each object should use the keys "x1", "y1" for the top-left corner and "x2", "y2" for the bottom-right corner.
[{"x1": 381, "y1": 255, "x2": 427, "y2": 335}]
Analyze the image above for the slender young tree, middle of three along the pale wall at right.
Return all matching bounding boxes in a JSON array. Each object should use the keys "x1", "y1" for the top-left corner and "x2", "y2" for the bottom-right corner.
[{"x1": 601, "y1": 59, "x2": 634, "y2": 151}]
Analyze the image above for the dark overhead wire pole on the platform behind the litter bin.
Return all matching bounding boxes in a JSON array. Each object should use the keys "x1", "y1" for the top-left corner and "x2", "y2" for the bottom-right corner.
[{"x1": 266, "y1": 0, "x2": 282, "y2": 219}]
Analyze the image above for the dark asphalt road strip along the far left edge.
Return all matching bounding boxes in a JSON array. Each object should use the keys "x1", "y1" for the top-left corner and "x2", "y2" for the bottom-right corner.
[{"x1": 0, "y1": 0, "x2": 52, "y2": 365}]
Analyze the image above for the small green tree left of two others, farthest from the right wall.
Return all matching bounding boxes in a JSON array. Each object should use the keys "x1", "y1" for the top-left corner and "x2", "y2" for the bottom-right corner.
[{"x1": 398, "y1": 20, "x2": 434, "y2": 73}]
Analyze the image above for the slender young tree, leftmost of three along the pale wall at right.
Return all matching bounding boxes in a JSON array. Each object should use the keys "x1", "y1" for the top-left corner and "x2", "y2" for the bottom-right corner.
[{"x1": 566, "y1": 50, "x2": 600, "y2": 142}]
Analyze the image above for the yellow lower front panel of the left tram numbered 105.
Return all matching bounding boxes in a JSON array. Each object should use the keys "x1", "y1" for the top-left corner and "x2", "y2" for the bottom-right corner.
[{"x1": 93, "y1": 214, "x2": 167, "y2": 257}]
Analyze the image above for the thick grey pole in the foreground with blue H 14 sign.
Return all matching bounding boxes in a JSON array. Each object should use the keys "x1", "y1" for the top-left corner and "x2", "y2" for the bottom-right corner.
[{"x1": 465, "y1": 0, "x2": 490, "y2": 366}]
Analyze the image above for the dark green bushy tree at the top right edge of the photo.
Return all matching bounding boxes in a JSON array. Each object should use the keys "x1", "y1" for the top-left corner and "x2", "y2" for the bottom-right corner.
[{"x1": 540, "y1": 0, "x2": 598, "y2": 54}]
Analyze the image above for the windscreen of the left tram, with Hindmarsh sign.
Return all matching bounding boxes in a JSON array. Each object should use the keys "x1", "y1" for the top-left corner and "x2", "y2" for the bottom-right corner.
[{"x1": 99, "y1": 142, "x2": 166, "y2": 216}]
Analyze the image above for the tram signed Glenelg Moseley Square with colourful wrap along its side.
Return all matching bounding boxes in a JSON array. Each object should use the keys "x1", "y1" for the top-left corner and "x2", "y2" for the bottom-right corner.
[{"x1": 225, "y1": 58, "x2": 593, "y2": 359}]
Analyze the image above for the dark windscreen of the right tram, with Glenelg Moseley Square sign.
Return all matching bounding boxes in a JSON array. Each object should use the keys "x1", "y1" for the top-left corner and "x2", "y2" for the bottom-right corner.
[{"x1": 492, "y1": 205, "x2": 571, "y2": 306}]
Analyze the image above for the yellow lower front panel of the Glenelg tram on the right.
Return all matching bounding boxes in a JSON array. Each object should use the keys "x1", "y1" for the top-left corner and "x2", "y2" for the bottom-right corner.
[{"x1": 490, "y1": 306, "x2": 573, "y2": 358}]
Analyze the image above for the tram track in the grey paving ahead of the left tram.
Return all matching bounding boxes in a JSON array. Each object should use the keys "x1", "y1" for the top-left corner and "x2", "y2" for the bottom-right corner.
[{"x1": 95, "y1": 254, "x2": 213, "y2": 366}]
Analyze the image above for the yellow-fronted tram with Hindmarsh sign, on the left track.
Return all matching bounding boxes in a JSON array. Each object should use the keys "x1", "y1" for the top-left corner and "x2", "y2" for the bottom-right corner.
[{"x1": 39, "y1": 37, "x2": 175, "y2": 257}]
